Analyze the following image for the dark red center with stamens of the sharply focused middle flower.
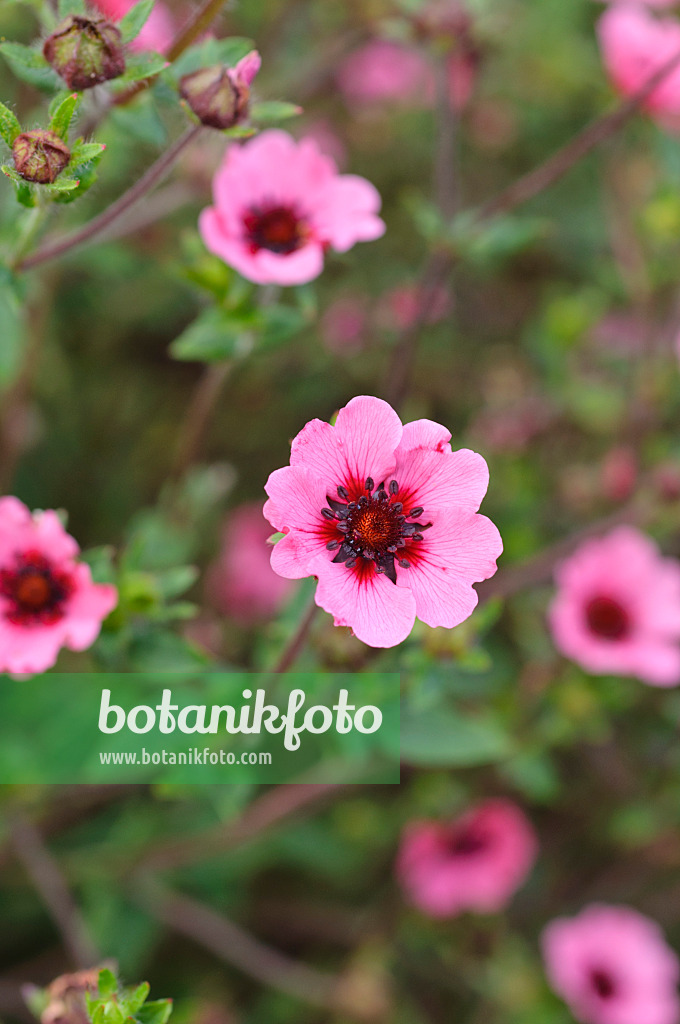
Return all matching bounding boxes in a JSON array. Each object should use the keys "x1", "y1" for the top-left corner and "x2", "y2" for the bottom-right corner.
[{"x1": 322, "y1": 477, "x2": 432, "y2": 583}]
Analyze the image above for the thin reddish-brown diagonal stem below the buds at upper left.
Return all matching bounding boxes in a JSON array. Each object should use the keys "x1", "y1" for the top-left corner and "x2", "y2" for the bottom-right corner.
[{"x1": 16, "y1": 125, "x2": 203, "y2": 270}]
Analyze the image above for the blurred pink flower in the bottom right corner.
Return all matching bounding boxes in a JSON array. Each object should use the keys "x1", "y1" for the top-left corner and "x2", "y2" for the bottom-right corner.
[{"x1": 543, "y1": 903, "x2": 680, "y2": 1024}]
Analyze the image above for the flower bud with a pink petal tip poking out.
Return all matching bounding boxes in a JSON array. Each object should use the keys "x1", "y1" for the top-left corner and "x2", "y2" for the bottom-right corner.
[{"x1": 179, "y1": 50, "x2": 260, "y2": 130}]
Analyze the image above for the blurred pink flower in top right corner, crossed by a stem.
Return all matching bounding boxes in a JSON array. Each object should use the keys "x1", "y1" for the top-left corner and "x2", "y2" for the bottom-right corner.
[{"x1": 598, "y1": 3, "x2": 680, "y2": 127}]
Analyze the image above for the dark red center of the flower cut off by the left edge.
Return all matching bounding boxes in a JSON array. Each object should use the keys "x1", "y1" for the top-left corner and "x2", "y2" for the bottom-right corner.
[{"x1": 0, "y1": 551, "x2": 75, "y2": 626}]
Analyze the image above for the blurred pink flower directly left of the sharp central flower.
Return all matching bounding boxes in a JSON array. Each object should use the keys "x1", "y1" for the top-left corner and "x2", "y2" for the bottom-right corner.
[{"x1": 207, "y1": 505, "x2": 292, "y2": 624}]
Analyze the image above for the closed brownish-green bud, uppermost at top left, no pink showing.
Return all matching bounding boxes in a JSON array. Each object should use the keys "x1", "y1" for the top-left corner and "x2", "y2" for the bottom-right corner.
[{"x1": 43, "y1": 14, "x2": 125, "y2": 91}]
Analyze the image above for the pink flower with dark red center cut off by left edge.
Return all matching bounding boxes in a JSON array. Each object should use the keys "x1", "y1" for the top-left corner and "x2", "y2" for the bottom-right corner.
[{"x1": 0, "y1": 498, "x2": 118, "y2": 673}]
